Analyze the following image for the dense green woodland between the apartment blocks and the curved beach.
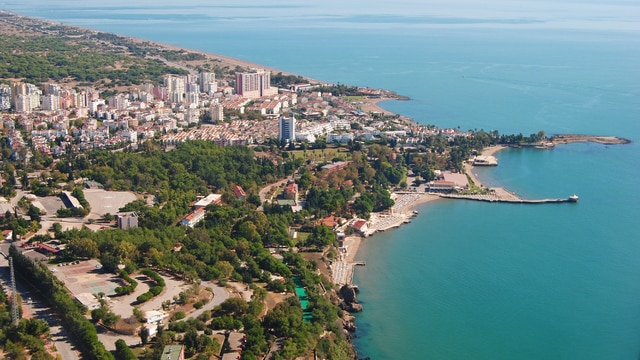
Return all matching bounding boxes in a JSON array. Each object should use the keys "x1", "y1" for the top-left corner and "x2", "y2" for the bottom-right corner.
[{"x1": 1, "y1": 141, "x2": 404, "y2": 359}]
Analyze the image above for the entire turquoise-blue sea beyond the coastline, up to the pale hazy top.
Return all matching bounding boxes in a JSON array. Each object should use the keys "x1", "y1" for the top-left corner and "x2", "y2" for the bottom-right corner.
[{"x1": 0, "y1": 0, "x2": 640, "y2": 360}]
